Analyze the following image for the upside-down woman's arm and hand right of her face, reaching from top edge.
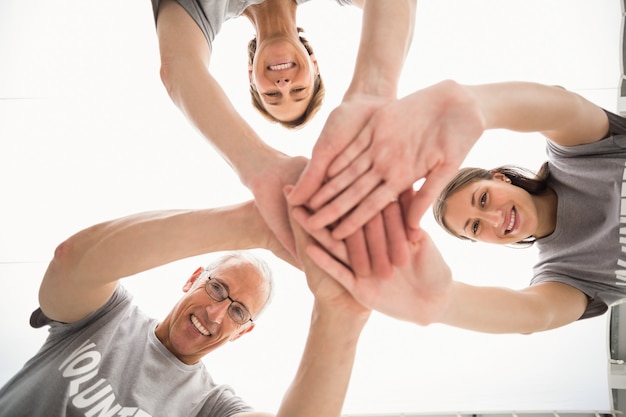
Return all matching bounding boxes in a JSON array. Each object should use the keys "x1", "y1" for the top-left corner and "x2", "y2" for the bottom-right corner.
[{"x1": 289, "y1": 0, "x2": 416, "y2": 217}]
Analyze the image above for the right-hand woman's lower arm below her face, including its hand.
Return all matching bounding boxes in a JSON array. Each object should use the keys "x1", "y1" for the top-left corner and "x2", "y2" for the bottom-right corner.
[{"x1": 294, "y1": 200, "x2": 587, "y2": 333}]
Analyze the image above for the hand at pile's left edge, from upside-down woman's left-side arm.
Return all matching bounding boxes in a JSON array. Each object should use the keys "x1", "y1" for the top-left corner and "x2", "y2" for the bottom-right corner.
[{"x1": 248, "y1": 155, "x2": 307, "y2": 258}]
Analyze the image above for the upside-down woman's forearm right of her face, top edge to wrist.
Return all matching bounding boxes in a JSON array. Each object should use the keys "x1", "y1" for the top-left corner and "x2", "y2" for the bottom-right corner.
[{"x1": 346, "y1": 0, "x2": 416, "y2": 99}]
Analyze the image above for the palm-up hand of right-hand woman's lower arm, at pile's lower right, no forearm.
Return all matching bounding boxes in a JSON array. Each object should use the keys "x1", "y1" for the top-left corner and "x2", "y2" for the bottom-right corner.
[{"x1": 294, "y1": 200, "x2": 452, "y2": 325}]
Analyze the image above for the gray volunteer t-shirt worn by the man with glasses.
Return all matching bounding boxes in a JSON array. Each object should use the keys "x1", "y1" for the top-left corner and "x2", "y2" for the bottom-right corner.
[{"x1": 0, "y1": 286, "x2": 252, "y2": 417}]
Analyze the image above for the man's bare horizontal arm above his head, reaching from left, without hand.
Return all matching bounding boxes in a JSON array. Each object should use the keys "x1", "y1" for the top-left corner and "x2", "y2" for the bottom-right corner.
[{"x1": 55, "y1": 202, "x2": 266, "y2": 283}]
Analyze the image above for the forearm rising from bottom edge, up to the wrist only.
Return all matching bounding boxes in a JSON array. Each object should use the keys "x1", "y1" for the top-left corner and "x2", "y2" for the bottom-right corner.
[{"x1": 277, "y1": 303, "x2": 369, "y2": 417}]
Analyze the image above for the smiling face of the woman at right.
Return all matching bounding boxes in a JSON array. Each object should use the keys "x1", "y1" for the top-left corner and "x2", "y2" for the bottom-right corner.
[{"x1": 444, "y1": 174, "x2": 539, "y2": 244}]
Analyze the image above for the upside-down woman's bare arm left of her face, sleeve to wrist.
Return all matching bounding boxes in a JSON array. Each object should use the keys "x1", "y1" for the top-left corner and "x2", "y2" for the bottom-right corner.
[{"x1": 157, "y1": 0, "x2": 277, "y2": 185}]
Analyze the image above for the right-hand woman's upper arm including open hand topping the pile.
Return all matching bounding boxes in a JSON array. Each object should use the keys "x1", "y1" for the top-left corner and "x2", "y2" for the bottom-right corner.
[{"x1": 290, "y1": 81, "x2": 608, "y2": 239}]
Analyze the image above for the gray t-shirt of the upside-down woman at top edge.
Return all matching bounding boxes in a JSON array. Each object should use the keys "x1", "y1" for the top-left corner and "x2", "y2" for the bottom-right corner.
[{"x1": 152, "y1": 0, "x2": 352, "y2": 48}]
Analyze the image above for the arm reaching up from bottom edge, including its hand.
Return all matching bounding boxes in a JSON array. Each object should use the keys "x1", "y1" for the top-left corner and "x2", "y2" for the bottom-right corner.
[{"x1": 242, "y1": 198, "x2": 370, "y2": 417}]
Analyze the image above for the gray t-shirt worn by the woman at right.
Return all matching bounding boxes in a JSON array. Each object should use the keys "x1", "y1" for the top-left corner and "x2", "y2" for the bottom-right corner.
[{"x1": 531, "y1": 112, "x2": 626, "y2": 319}]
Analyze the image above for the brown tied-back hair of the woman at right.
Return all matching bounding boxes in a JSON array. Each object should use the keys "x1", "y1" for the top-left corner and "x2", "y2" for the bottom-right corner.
[{"x1": 433, "y1": 162, "x2": 550, "y2": 246}]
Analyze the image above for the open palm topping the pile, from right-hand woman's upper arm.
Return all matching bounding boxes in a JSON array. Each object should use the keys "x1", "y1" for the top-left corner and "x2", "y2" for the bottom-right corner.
[{"x1": 290, "y1": 81, "x2": 485, "y2": 239}]
